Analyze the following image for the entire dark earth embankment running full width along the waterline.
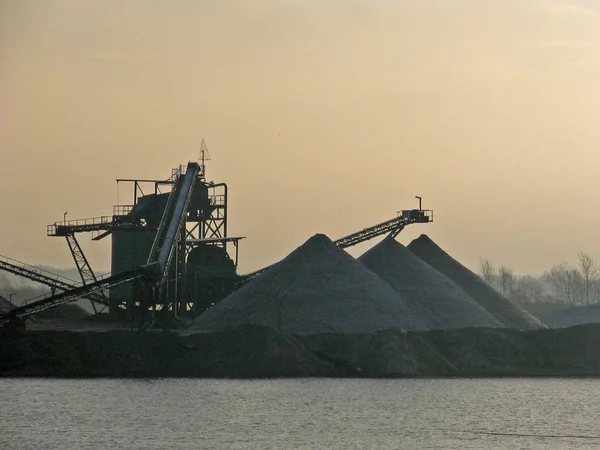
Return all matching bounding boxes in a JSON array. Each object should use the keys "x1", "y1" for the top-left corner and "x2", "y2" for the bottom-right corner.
[{"x1": 0, "y1": 324, "x2": 600, "y2": 378}]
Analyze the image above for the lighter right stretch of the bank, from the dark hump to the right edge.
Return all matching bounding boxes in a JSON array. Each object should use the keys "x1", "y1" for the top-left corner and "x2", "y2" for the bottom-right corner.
[{"x1": 303, "y1": 325, "x2": 600, "y2": 377}]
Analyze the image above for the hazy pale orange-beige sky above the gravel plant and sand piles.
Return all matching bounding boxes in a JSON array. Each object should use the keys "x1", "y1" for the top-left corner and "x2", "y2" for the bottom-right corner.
[{"x1": 0, "y1": 0, "x2": 600, "y2": 274}]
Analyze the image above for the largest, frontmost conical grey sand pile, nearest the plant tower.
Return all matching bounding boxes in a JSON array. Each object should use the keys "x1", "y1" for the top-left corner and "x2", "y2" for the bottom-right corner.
[{"x1": 191, "y1": 234, "x2": 426, "y2": 334}]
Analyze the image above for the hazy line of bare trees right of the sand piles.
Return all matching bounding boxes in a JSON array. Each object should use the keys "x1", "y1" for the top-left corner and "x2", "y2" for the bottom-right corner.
[{"x1": 479, "y1": 252, "x2": 600, "y2": 306}]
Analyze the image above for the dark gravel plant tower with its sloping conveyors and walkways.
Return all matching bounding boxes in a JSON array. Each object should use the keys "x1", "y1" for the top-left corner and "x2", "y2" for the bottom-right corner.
[{"x1": 0, "y1": 151, "x2": 433, "y2": 324}]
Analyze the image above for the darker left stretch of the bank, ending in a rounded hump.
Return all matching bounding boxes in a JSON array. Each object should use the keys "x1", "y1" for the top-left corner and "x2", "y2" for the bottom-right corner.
[{"x1": 0, "y1": 325, "x2": 335, "y2": 378}]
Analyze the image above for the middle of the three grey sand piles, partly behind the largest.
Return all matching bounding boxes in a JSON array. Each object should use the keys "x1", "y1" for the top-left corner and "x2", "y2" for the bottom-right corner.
[{"x1": 359, "y1": 237, "x2": 504, "y2": 330}]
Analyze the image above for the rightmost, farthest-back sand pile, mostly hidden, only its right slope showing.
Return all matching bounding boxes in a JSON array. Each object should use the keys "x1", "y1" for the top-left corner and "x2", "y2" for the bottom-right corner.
[{"x1": 408, "y1": 234, "x2": 544, "y2": 330}]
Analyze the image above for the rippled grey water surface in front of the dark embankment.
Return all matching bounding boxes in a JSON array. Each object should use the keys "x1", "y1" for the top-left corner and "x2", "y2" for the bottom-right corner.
[{"x1": 0, "y1": 378, "x2": 600, "y2": 450}]
